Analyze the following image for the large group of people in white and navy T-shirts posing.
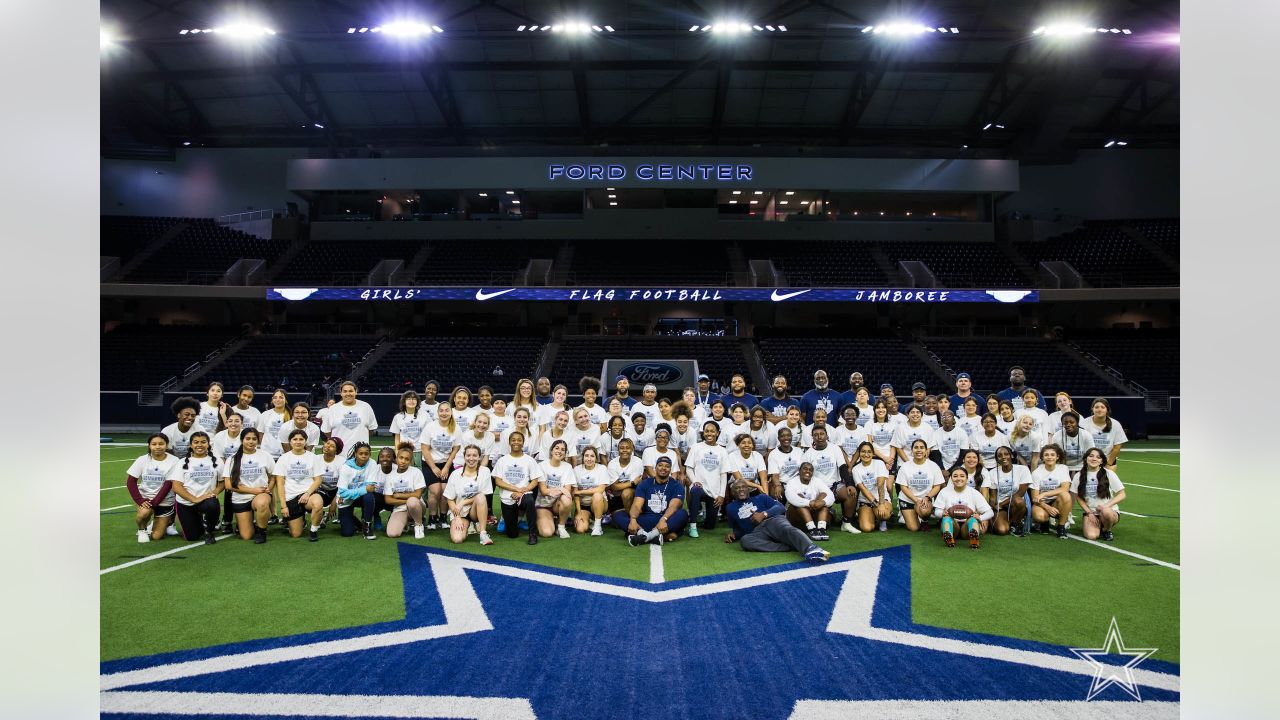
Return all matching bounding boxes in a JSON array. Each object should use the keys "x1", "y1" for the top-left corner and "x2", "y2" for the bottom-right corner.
[{"x1": 127, "y1": 366, "x2": 1128, "y2": 562}]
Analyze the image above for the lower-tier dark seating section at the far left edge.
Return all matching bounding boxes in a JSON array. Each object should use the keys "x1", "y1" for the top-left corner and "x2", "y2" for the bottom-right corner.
[{"x1": 100, "y1": 325, "x2": 242, "y2": 389}]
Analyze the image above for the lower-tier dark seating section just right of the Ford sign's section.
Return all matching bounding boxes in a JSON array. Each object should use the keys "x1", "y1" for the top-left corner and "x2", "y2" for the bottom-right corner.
[{"x1": 756, "y1": 329, "x2": 948, "y2": 396}]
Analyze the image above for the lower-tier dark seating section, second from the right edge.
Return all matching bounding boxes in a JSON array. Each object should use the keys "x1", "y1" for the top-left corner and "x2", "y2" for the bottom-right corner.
[{"x1": 921, "y1": 337, "x2": 1117, "y2": 397}]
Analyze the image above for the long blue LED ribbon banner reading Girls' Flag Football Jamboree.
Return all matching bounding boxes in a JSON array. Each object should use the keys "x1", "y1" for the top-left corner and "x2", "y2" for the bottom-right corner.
[{"x1": 266, "y1": 287, "x2": 1039, "y2": 304}]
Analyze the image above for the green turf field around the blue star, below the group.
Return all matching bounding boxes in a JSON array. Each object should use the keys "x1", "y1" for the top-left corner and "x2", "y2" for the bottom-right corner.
[{"x1": 99, "y1": 436, "x2": 1181, "y2": 662}]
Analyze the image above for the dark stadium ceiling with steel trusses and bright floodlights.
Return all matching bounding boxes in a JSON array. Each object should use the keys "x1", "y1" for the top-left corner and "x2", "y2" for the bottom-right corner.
[{"x1": 101, "y1": 0, "x2": 1179, "y2": 160}]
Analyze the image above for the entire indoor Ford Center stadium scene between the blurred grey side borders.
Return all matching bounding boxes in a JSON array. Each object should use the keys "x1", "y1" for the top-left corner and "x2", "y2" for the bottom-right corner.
[{"x1": 97, "y1": 0, "x2": 1182, "y2": 720}]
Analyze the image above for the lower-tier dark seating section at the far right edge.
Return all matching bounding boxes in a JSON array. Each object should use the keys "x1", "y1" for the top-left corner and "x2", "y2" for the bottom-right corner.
[{"x1": 1069, "y1": 328, "x2": 1179, "y2": 395}]
